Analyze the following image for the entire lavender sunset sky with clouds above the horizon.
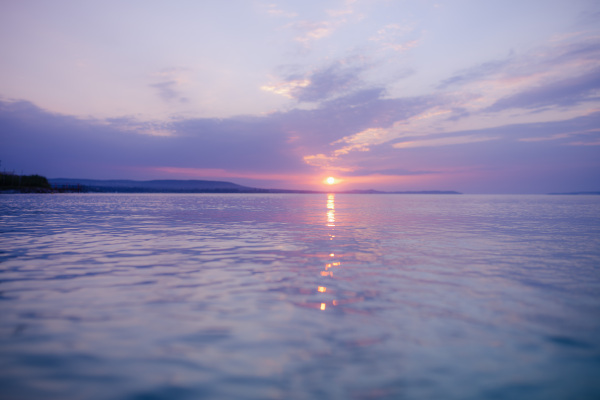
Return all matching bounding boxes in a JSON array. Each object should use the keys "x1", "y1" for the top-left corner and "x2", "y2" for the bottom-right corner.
[{"x1": 0, "y1": 0, "x2": 600, "y2": 194}]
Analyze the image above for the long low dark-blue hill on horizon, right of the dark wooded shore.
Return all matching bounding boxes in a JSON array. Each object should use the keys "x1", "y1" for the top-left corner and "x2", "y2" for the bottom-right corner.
[{"x1": 49, "y1": 178, "x2": 267, "y2": 193}]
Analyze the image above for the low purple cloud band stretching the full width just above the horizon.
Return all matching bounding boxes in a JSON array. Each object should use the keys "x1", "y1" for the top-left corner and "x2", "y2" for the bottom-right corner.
[{"x1": 0, "y1": 97, "x2": 600, "y2": 191}]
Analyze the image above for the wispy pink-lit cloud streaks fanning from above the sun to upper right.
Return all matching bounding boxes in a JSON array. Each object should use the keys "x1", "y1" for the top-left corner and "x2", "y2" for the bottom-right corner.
[{"x1": 284, "y1": 33, "x2": 600, "y2": 181}]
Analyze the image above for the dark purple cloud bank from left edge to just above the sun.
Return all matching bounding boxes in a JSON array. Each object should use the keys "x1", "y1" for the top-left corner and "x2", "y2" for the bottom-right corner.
[{"x1": 0, "y1": 89, "x2": 440, "y2": 183}]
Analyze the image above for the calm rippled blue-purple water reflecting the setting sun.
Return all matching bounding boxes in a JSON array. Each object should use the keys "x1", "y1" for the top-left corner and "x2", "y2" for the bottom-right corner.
[{"x1": 0, "y1": 194, "x2": 600, "y2": 399}]
